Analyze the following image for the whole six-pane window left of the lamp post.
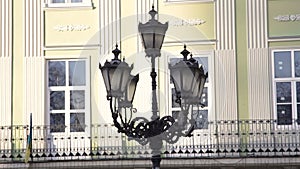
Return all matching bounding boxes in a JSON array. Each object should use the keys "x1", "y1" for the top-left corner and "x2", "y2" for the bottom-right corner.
[{"x1": 47, "y1": 59, "x2": 89, "y2": 133}]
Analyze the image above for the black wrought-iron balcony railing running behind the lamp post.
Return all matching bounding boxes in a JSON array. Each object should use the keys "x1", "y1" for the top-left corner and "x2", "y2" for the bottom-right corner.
[{"x1": 0, "y1": 120, "x2": 300, "y2": 163}]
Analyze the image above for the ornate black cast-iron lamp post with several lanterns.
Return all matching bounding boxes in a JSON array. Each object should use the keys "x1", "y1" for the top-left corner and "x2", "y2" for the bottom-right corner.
[{"x1": 99, "y1": 6, "x2": 207, "y2": 169}]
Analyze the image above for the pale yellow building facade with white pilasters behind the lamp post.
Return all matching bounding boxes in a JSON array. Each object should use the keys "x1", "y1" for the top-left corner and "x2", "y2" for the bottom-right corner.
[{"x1": 0, "y1": 0, "x2": 300, "y2": 167}]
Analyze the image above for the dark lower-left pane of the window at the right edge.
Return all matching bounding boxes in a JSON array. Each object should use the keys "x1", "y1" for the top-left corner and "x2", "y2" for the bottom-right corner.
[{"x1": 277, "y1": 104, "x2": 292, "y2": 125}]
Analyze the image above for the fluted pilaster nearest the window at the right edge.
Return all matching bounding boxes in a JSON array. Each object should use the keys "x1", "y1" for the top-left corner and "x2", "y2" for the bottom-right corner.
[{"x1": 247, "y1": 0, "x2": 271, "y2": 119}]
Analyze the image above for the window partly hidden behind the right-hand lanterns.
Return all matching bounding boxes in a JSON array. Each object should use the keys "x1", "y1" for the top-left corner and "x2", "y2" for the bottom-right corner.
[{"x1": 170, "y1": 55, "x2": 211, "y2": 129}]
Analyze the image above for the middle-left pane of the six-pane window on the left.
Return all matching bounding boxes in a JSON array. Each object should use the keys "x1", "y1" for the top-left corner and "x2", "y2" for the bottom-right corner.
[{"x1": 50, "y1": 91, "x2": 65, "y2": 110}]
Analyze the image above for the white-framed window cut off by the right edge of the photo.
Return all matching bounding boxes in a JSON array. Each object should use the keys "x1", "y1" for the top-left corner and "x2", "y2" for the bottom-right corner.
[{"x1": 272, "y1": 50, "x2": 300, "y2": 125}]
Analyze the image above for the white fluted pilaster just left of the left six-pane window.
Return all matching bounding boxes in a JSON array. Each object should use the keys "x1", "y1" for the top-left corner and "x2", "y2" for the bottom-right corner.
[{"x1": 23, "y1": 0, "x2": 45, "y2": 125}]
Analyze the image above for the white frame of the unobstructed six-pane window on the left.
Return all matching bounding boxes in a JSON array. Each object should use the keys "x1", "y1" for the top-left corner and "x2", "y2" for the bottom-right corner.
[{"x1": 46, "y1": 58, "x2": 91, "y2": 136}]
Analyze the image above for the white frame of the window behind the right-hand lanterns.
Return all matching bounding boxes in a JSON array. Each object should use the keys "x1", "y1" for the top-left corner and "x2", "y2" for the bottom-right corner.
[{"x1": 168, "y1": 52, "x2": 215, "y2": 131}]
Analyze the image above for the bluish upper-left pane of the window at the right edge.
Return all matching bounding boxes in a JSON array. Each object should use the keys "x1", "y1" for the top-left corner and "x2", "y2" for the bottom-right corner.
[{"x1": 274, "y1": 52, "x2": 292, "y2": 78}]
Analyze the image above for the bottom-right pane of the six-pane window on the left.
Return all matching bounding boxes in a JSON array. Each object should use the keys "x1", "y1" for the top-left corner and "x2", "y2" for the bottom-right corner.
[{"x1": 70, "y1": 113, "x2": 85, "y2": 132}]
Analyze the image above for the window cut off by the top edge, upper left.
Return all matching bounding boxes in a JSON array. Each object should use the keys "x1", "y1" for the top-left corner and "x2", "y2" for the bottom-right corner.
[{"x1": 46, "y1": 0, "x2": 92, "y2": 7}]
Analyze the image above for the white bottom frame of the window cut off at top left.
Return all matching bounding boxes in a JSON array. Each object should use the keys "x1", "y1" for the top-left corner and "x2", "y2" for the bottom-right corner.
[{"x1": 45, "y1": 0, "x2": 92, "y2": 8}]
